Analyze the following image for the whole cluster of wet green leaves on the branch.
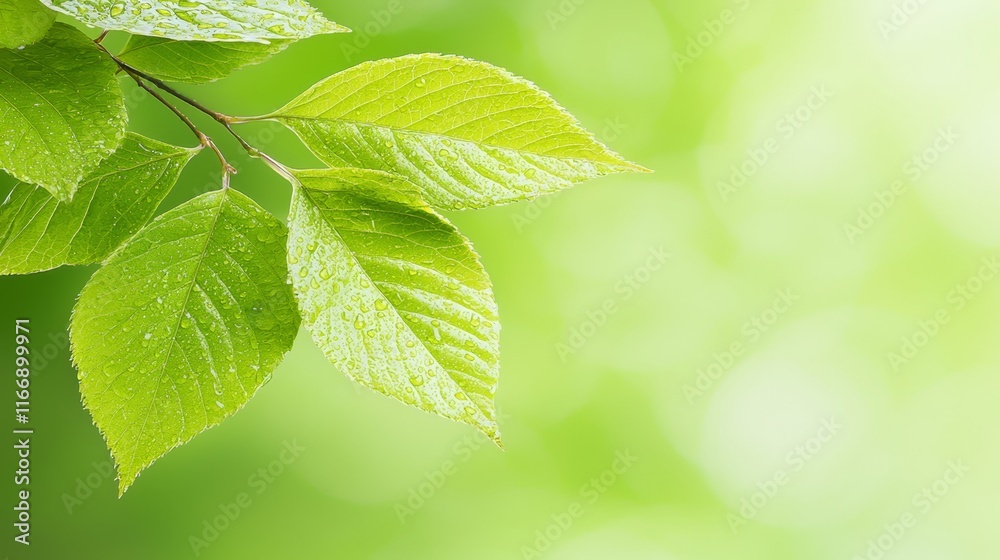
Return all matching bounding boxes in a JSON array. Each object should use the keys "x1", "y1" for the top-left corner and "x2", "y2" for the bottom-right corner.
[{"x1": 0, "y1": 0, "x2": 646, "y2": 492}]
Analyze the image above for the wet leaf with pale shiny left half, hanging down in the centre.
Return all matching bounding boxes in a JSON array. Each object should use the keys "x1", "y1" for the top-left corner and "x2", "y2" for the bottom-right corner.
[{"x1": 288, "y1": 169, "x2": 500, "y2": 444}]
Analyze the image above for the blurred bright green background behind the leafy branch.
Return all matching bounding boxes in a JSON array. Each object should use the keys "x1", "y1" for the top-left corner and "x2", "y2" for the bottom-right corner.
[{"x1": 0, "y1": 0, "x2": 1000, "y2": 560}]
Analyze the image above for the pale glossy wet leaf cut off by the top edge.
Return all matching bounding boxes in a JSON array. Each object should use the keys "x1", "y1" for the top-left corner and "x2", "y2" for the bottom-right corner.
[{"x1": 42, "y1": 0, "x2": 350, "y2": 43}]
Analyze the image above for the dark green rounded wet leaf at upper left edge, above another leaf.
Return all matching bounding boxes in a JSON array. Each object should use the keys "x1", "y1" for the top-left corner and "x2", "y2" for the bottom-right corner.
[{"x1": 0, "y1": 23, "x2": 128, "y2": 201}]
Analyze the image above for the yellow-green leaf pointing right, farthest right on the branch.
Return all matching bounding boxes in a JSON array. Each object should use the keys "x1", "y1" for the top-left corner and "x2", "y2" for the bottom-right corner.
[{"x1": 258, "y1": 54, "x2": 645, "y2": 210}]
